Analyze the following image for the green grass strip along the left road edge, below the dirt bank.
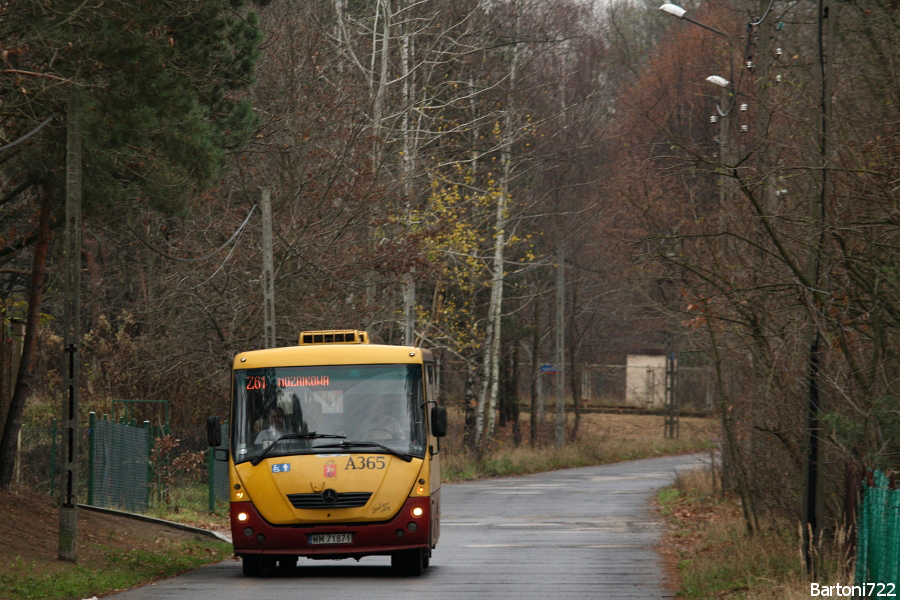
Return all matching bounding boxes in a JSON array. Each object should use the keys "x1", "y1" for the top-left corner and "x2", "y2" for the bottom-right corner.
[{"x1": 0, "y1": 540, "x2": 231, "y2": 600}]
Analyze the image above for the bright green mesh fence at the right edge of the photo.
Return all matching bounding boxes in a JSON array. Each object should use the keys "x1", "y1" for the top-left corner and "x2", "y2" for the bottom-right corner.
[{"x1": 855, "y1": 471, "x2": 900, "y2": 585}]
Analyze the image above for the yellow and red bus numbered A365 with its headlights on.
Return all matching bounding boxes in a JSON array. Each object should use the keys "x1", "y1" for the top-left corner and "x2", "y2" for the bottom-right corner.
[{"x1": 207, "y1": 330, "x2": 447, "y2": 576}]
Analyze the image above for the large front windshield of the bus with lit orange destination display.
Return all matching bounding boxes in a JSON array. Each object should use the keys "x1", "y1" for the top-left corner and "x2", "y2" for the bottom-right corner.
[{"x1": 232, "y1": 365, "x2": 426, "y2": 463}]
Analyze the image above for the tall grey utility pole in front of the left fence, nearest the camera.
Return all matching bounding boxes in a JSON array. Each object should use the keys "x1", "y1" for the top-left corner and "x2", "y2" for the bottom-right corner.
[{"x1": 59, "y1": 86, "x2": 81, "y2": 562}]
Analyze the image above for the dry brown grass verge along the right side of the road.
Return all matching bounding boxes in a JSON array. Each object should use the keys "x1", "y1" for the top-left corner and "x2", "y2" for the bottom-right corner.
[{"x1": 658, "y1": 469, "x2": 852, "y2": 600}]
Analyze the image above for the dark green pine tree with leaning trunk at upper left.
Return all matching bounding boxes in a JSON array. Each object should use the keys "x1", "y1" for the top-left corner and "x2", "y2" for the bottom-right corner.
[{"x1": 0, "y1": 0, "x2": 261, "y2": 486}]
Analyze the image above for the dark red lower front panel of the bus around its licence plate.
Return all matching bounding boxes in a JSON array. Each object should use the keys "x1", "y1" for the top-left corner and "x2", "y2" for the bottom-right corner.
[{"x1": 231, "y1": 498, "x2": 431, "y2": 558}]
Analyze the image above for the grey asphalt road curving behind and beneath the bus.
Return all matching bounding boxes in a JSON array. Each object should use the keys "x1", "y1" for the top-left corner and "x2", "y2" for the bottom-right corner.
[{"x1": 109, "y1": 455, "x2": 706, "y2": 600}]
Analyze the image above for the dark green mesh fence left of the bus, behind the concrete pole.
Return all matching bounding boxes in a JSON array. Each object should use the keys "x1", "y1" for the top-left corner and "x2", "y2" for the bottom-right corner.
[{"x1": 15, "y1": 413, "x2": 229, "y2": 514}]
